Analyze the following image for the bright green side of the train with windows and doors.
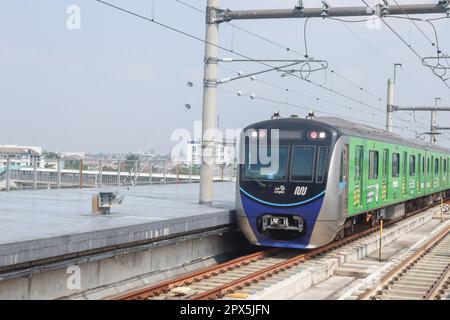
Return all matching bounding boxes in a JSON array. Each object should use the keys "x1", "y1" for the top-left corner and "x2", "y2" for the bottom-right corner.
[{"x1": 348, "y1": 137, "x2": 450, "y2": 216}]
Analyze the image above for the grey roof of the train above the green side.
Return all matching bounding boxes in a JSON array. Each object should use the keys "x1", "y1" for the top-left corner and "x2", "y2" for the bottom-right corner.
[{"x1": 314, "y1": 117, "x2": 450, "y2": 153}]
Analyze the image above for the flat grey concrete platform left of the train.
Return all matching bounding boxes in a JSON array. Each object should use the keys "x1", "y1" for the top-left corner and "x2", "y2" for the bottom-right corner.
[{"x1": 0, "y1": 182, "x2": 235, "y2": 268}]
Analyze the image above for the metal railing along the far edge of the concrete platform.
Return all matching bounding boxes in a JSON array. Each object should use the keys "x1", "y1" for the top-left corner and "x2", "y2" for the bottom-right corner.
[{"x1": 0, "y1": 159, "x2": 236, "y2": 191}]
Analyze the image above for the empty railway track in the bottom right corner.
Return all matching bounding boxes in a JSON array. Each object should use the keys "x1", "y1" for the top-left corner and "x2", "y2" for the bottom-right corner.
[{"x1": 358, "y1": 227, "x2": 450, "y2": 300}]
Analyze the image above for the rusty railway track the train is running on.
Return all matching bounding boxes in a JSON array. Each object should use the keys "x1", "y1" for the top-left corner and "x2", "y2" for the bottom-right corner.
[{"x1": 112, "y1": 202, "x2": 446, "y2": 300}]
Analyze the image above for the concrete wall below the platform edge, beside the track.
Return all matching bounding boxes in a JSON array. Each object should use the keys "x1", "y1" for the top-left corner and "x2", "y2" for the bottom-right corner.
[{"x1": 0, "y1": 232, "x2": 249, "y2": 300}]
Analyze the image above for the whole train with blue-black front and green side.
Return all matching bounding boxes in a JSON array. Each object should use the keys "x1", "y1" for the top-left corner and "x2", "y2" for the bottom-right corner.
[{"x1": 236, "y1": 117, "x2": 450, "y2": 249}]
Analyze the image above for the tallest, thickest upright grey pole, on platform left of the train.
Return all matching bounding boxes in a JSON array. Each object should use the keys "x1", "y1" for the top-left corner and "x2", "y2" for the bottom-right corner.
[{"x1": 200, "y1": 0, "x2": 219, "y2": 204}]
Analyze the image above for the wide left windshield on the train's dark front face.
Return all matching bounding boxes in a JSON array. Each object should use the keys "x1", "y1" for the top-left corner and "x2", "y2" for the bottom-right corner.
[{"x1": 243, "y1": 146, "x2": 289, "y2": 181}]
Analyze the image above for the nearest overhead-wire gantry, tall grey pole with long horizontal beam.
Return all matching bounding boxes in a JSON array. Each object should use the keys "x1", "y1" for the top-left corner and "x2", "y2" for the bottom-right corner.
[{"x1": 200, "y1": 0, "x2": 450, "y2": 204}]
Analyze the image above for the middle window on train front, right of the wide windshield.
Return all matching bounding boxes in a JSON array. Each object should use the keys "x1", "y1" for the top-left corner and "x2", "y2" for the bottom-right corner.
[{"x1": 291, "y1": 146, "x2": 316, "y2": 182}]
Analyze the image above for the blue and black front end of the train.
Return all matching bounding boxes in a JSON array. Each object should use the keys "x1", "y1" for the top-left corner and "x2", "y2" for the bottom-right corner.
[{"x1": 236, "y1": 118, "x2": 345, "y2": 249}]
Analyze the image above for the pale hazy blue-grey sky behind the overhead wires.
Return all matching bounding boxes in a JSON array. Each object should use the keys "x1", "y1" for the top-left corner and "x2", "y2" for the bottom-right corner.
[{"x1": 0, "y1": 0, "x2": 450, "y2": 153}]
